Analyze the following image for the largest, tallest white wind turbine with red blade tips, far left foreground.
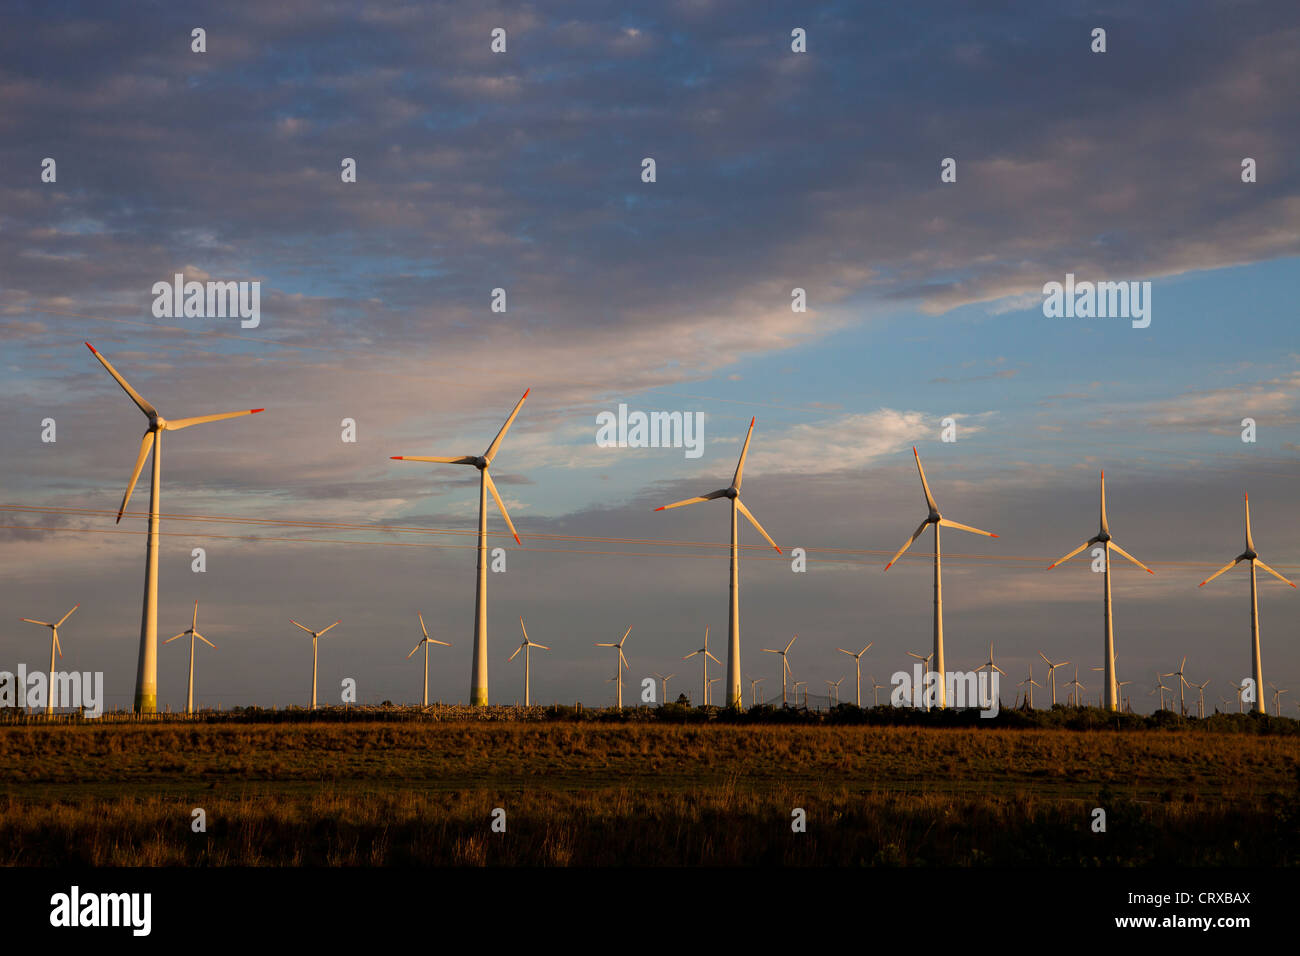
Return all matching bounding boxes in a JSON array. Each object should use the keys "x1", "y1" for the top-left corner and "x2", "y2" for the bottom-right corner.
[{"x1": 86, "y1": 342, "x2": 265, "y2": 714}]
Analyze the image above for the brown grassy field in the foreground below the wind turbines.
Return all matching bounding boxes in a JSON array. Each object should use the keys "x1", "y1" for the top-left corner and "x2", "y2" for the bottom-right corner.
[{"x1": 0, "y1": 708, "x2": 1300, "y2": 866}]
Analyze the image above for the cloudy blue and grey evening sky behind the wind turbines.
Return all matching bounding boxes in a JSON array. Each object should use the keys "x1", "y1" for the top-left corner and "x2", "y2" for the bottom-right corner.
[{"x1": 0, "y1": 0, "x2": 1300, "y2": 711}]
